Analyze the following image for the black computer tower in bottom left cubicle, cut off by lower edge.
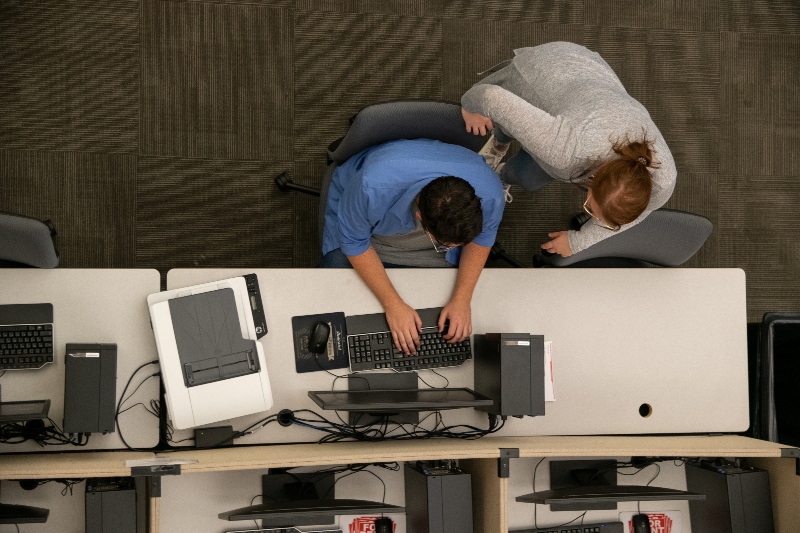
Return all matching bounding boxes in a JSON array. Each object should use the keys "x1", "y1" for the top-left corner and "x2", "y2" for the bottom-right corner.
[{"x1": 86, "y1": 477, "x2": 147, "y2": 533}]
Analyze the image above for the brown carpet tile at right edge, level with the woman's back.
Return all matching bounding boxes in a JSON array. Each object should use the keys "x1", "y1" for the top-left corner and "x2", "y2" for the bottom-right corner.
[{"x1": 720, "y1": 34, "x2": 800, "y2": 176}]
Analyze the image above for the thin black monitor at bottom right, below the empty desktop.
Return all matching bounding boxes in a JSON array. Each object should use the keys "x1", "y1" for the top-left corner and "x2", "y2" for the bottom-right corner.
[{"x1": 517, "y1": 485, "x2": 706, "y2": 505}]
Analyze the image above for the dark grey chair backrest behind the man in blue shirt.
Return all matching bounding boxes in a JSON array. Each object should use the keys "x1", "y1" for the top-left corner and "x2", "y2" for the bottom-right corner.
[{"x1": 328, "y1": 100, "x2": 486, "y2": 165}]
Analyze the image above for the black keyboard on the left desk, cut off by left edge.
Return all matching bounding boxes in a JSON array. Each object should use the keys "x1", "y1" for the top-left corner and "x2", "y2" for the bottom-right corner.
[{"x1": 0, "y1": 304, "x2": 53, "y2": 370}]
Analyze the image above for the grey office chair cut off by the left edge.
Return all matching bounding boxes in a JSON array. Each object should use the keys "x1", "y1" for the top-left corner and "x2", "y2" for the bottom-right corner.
[{"x1": 0, "y1": 213, "x2": 58, "y2": 268}]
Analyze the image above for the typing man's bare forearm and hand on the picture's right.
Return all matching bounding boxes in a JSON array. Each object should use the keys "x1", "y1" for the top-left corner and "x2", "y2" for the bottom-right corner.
[{"x1": 439, "y1": 242, "x2": 491, "y2": 342}]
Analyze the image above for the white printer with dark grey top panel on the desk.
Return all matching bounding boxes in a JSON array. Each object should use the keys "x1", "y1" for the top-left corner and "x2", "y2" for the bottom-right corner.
[{"x1": 147, "y1": 277, "x2": 272, "y2": 429}]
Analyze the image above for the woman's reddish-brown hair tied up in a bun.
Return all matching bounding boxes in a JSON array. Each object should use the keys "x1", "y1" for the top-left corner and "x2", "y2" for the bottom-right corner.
[{"x1": 588, "y1": 132, "x2": 658, "y2": 226}]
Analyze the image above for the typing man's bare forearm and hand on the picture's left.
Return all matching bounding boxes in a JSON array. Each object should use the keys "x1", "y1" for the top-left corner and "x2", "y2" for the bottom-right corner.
[{"x1": 348, "y1": 246, "x2": 424, "y2": 354}]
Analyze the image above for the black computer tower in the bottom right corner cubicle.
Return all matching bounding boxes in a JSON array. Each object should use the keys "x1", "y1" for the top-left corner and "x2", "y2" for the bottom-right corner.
[{"x1": 686, "y1": 463, "x2": 774, "y2": 533}]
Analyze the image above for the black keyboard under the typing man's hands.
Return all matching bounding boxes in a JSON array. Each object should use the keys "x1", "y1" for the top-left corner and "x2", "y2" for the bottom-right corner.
[{"x1": 346, "y1": 307, "x2": 472, "y2": 372}]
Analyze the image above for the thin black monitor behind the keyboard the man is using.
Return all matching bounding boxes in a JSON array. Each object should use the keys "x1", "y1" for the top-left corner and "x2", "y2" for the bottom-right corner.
[{"x1": 308, "y1": 388, "x2": 493, "y2": 413}]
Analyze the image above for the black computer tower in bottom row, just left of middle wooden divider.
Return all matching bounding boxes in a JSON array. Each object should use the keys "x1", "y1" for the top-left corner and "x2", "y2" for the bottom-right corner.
[{"x1": 405, "y1": 463, "x2": 472, "y2": 533}]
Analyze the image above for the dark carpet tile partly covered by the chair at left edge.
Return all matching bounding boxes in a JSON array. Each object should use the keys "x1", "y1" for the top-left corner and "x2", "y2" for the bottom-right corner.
[{"x1": 0, "y1": 150, "x2": 136, "y2": 268}]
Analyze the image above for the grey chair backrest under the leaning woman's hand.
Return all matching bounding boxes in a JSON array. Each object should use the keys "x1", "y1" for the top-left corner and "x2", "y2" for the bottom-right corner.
[{"x1": 537, "y1": 209, "x2": 713, "y2": 267}]
